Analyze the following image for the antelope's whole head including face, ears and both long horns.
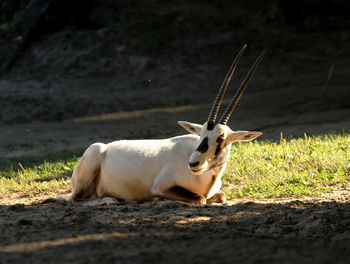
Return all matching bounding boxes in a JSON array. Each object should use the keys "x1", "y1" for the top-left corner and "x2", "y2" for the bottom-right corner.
[{"x1": 178, "y1": 45, "x2": 266, "y2": 175}]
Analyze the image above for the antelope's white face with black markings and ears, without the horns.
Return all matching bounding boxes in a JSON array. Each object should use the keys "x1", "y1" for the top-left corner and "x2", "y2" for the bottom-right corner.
[{"x1": 178, "y1": 121, "x2": 262, "y2": 175}]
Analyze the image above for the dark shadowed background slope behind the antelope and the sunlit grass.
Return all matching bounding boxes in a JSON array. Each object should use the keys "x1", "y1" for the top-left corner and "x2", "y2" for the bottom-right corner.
[{"x1": 0, "y1": 0, "x2": 350, "y2": 157}]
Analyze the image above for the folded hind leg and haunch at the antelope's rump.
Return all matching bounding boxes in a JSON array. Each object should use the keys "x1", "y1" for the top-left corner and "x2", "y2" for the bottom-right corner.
[{"x1": 68, "y1": 143, "x2": 106, "y2": 204}]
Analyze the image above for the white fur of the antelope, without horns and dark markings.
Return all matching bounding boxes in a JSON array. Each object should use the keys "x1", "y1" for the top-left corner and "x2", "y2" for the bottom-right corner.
[{"x1": 69, "y1": 119, "x2": 260, "y2": 202}]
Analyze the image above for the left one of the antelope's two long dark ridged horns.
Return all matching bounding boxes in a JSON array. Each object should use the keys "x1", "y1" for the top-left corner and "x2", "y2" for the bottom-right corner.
[{"x1": 207, "y1": 44, "x2": 247, "y2": 130}]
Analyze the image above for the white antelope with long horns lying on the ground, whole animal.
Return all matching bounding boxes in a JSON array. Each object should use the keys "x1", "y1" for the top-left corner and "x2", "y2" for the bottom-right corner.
[{"x1": 68, "y1": 45, "x2": 266, "y2": 205}]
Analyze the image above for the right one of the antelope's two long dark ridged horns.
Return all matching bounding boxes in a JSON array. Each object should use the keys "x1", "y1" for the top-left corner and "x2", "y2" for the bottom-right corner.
[{"x1": 219, "y1": 49, "x2": 266, "y2": 125}]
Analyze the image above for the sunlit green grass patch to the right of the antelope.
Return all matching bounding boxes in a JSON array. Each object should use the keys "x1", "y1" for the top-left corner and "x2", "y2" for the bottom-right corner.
[{"x1": 223, "y1": 133, "x2": 350, "y2": 199}]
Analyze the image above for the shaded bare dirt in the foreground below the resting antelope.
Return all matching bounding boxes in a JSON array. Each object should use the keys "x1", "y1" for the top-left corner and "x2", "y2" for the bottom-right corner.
[{"x1": 0, "y1": 192, "x2": 350, "y2": 263}]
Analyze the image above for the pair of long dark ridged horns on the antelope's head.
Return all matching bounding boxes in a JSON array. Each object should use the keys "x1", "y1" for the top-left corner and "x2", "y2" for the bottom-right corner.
[{"x1": 207, "y1": 44, "x2": 266, "y2": 130}]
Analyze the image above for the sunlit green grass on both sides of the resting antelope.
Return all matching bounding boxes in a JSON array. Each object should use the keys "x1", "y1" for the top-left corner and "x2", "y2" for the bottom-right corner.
[{"x1": 0, "y1": 133, "x2": 350, "y2": 199}]
